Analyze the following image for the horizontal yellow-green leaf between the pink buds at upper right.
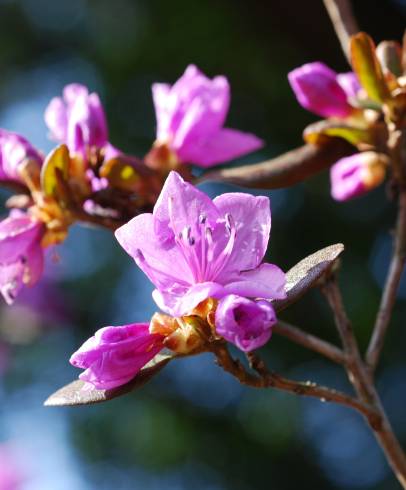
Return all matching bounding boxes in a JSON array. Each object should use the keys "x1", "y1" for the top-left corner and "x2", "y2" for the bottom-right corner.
[{"x1": 303, "y1": 119, "x2": 373, "y2": 145}]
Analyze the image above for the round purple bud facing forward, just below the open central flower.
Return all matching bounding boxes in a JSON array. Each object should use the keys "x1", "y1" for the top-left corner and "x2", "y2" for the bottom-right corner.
[{"x1": 215, "y1": 294, "x2": 276, "y2": 352}]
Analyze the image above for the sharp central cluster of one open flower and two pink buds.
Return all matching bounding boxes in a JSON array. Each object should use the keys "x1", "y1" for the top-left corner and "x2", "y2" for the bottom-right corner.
[{"x1": 71, "y1": 172, "x2": 286, "y2": 389}]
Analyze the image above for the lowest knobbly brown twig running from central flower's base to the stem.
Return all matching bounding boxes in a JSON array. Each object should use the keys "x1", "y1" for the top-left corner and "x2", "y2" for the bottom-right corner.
[{"x1": 212, "y1": 344, "x2": 379, "y2": 424}]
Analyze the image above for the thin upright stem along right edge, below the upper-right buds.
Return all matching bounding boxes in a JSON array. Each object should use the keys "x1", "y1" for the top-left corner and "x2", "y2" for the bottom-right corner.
[{"x1": 366, "y1": 190, "x2": 406, "y2": 372}]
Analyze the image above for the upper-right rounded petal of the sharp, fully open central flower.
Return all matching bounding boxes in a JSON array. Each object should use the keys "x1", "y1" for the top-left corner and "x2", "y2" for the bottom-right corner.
[{"x1": 213, "y1": 192, "x2": 271, "y2": 272}]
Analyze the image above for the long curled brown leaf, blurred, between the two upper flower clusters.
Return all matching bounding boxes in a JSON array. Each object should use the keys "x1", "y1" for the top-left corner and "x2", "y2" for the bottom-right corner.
[{"x1": 198, "y1": 138, "x2": 356, "y2": 189}]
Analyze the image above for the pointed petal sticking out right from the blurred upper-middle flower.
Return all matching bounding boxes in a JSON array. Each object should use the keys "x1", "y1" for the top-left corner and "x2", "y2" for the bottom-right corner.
[{"x1": 178, "y1": 128, "x2": 264, "y2": 167}]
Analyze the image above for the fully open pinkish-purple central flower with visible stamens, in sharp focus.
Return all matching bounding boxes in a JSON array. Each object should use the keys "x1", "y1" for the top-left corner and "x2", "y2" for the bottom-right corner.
[{"x1": 116, "y1": 172, "x2": 285, "y2": 316}]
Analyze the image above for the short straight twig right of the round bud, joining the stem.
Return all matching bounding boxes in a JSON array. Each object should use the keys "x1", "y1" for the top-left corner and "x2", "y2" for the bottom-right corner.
[{"x1": 273, "y1": 321, "x2": 346, "y2": 364}]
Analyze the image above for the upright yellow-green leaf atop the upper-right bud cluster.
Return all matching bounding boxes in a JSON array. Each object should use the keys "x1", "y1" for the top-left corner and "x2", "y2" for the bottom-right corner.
[{"x1": 350, "y1": 32, "x2": 390, "y2": 104}]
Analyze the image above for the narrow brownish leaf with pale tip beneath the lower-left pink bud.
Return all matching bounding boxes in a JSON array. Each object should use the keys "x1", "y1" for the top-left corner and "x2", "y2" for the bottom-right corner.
[{"x1": 44, "y1": 354, "x2": 174, "y2": 407}]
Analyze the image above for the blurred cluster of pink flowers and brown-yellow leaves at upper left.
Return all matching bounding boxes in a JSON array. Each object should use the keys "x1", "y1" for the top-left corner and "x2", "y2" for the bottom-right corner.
[{"x1": 0, "y1": 66, "x2": 262, "y2": 304}]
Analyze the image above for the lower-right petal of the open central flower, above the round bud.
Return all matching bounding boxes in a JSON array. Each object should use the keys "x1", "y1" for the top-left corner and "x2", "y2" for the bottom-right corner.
[{"x1": 224, "y1": 264, "x2": 286, "y2": 299}]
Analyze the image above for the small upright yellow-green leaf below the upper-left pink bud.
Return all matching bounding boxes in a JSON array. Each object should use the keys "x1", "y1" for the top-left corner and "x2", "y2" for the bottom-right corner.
[{"x1": 41, "y1": 145, "x2": 70, "y2": 197}]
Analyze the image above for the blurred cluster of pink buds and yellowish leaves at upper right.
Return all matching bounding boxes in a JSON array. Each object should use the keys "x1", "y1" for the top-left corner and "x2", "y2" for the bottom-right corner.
[{"x1": 288, "y1": 33, "x2": 405, "y2": 201}]
